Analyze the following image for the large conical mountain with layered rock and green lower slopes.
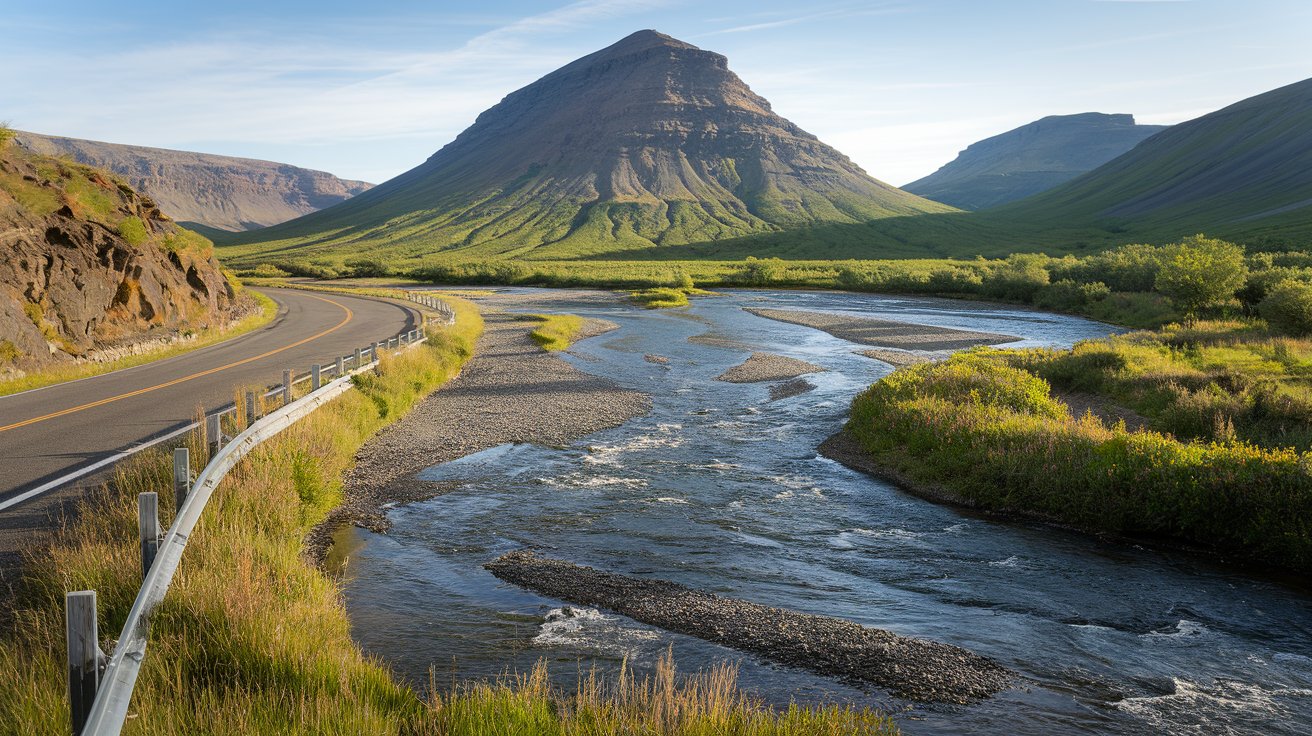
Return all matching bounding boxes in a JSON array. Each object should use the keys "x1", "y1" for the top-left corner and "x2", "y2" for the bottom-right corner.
[{"x1": 232, "y1": 30, "x2": 951, "y2": 260}]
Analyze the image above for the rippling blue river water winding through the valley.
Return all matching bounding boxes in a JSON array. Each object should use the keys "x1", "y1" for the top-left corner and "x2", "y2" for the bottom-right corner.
[{"x1": 344, "y1": 291, "x2": 1312, "y2": 735}]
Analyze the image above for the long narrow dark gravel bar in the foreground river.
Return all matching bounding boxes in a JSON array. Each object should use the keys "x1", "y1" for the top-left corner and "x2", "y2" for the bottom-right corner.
[{"x1": 484, "y1": 551, "x2": 1014, "y2": 703}]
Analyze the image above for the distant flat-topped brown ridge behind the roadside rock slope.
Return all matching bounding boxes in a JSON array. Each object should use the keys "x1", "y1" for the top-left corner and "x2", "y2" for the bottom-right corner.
[{"x1": 16, "y1": 133, "x2": 373, "y2": 231}]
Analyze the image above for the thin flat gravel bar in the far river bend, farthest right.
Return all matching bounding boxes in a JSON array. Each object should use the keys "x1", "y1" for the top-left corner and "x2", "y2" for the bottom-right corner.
[{"x1": 747, "y1": 308, "x2": 1019, "y2": 350}]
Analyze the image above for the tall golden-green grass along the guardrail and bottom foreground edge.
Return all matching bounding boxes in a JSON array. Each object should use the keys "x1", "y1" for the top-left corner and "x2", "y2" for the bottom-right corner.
[{"x1": 0, "y1": 293, "x2": 896, "y2": 736}]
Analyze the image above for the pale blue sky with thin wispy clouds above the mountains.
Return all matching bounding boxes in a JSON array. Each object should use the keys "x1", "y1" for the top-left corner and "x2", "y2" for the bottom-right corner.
[{"x1": 0, "y1": 0, "x2": 1312, "y2": 185}]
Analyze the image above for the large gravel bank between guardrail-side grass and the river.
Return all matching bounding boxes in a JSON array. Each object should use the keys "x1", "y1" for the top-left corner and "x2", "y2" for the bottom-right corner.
[{"x1": 306, "y1": 306, "x2": 651, "y2": 563}]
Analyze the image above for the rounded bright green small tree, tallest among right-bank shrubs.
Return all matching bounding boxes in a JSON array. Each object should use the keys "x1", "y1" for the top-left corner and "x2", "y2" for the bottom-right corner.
[{"x1": 1155, "y1": 235, "x2": 1248, "y2": 317}]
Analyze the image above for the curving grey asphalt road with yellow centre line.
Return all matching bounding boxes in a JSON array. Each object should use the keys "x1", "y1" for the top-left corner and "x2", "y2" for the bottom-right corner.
[{"x1": 0, "y1": 289, "x2": 419, "y2": 516}]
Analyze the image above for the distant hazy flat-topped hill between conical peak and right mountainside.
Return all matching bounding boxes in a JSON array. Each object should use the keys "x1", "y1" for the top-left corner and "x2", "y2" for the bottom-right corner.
[{"x1": 903, "y1": 113, "x2": 1166, "y2": 210}]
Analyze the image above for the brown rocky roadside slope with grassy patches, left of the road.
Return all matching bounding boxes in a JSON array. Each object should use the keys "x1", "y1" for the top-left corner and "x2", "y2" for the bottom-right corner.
[{"x1": 0, "y1": 140, "x2": 245, "y2": 374}]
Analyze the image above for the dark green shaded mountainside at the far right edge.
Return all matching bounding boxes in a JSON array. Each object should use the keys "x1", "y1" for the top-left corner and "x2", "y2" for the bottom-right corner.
[{"x1": 996, "y1": 79, "x2": 1312, "y2": 247}]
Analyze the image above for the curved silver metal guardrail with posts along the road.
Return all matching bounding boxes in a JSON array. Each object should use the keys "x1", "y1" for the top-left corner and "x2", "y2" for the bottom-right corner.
[{"x1": 66, "y1": 294, "x2": 455, "y2": 736}]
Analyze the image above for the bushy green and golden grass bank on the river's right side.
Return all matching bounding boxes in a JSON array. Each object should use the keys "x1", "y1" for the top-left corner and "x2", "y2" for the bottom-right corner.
[{"x1": 848, "y1": 331, "x2": 1312, "y2": 573}]
